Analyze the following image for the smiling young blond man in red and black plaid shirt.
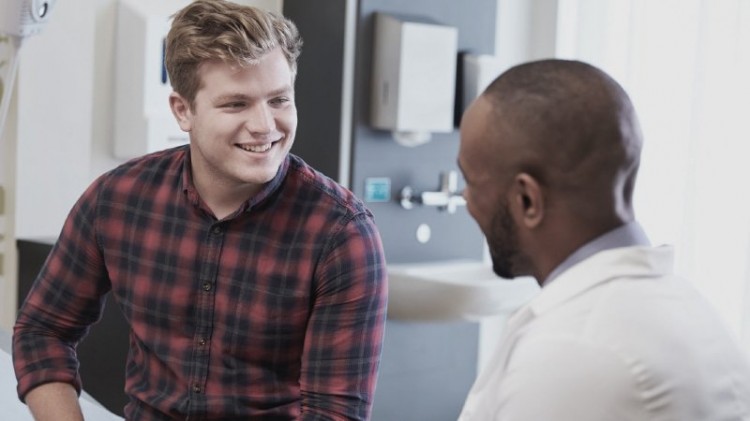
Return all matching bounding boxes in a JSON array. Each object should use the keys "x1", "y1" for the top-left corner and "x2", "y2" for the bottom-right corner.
[{"x1": 14, "y1": 0, "x2": 387, "y2": 420}]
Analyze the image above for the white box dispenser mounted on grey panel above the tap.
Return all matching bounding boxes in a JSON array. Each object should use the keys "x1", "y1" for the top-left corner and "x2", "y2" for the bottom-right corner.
[{"x1": 370, "y1": 13, "x2": 458, "y2": 146}]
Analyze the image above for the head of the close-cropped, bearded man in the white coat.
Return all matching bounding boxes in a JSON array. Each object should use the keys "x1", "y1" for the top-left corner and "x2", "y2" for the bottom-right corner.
[{"x1": 458, "y1": 60, "x2": 641, "y2": 280}]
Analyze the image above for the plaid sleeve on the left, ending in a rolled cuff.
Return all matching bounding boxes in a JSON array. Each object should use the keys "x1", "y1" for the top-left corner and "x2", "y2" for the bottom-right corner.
[{"x1": 13, "y1": 177, "x2": 109, "y2": 401}]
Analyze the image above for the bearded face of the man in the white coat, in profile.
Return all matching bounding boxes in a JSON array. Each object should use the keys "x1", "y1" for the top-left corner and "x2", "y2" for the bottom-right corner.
[{"x1": 458, "y1": 97, "x2": 523, "y2": 278}]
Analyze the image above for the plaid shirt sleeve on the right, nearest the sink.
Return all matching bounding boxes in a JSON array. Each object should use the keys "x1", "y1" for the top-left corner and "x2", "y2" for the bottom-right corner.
[{"x1": 300, "y1": 214, "x2": 388, "y2": 421}]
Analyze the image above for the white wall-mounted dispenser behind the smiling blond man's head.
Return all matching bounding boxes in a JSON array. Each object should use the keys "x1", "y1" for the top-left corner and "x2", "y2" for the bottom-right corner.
[{"x1": 114, "y1": 0, "x2": 189, "y2": 159}]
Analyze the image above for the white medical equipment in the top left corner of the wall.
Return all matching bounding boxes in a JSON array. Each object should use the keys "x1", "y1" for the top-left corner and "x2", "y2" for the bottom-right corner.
[{"x1": 0, "y1": 0, "x2": 57, "y2": 134}]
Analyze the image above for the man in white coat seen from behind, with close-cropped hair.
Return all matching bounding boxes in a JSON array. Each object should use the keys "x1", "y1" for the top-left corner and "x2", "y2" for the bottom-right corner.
[{"x1": 458, "y1": 60, "x2": 750, "y2": 421}]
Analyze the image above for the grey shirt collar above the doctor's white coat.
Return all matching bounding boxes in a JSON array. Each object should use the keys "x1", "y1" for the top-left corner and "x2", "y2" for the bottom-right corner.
[{"x1": 542, "y1": 221, "x2": 651, "y2": 286}]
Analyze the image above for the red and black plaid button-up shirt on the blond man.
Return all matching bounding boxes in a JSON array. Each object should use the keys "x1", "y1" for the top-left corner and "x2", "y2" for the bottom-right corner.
[{"x1": 14, "y1": 147, "x2": 387, "y2": 420}]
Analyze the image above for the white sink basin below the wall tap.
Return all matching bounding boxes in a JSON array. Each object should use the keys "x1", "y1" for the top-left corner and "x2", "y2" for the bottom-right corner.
[{"x1": 388, "y1": 260, "x2": 539, "y2": 321}]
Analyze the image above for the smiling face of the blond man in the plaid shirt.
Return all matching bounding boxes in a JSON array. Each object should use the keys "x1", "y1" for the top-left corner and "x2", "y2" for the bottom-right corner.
[{"x1": 173, "y1": 49, "x2": 297, "y2": 190}]
